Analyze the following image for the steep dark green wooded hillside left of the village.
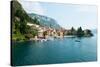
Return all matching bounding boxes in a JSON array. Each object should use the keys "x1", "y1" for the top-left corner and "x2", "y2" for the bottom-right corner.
[{"x1": 11, "y1": 1, "x2": 39, "y2": 41}]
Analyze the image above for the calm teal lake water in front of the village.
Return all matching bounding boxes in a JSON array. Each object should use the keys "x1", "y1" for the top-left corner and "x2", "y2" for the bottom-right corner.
[{"x1": 12, "y1": 35, "x2": 97, "y2": 65}]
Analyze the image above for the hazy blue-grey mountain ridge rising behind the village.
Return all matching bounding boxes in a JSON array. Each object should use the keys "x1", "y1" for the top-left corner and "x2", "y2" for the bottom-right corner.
[{"x1": 28, "y1": 13, "x2": 61, "y2": 29}]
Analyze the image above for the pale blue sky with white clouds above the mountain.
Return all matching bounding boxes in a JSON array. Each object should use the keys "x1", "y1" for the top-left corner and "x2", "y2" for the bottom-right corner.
[{"x1": 19, "y1": 0, "x2": 97, "y2": 29}]
